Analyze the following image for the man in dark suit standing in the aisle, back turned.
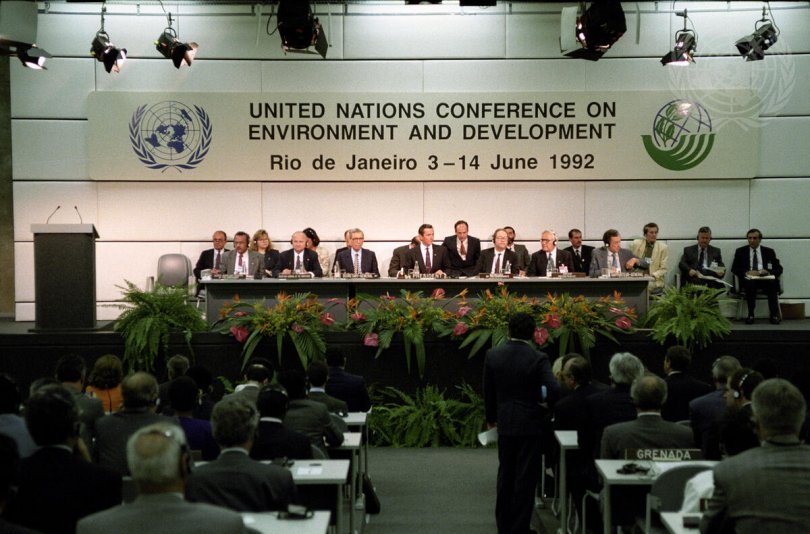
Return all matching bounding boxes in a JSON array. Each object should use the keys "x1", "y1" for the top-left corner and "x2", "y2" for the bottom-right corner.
[{"x1": 484, "y1": 313, "x2": 559, "y2": 533}]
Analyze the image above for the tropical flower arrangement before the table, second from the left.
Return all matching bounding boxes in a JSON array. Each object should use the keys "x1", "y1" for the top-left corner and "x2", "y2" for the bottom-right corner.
[{"x1": 346, "y1": 288, "x2": 453, "y2": 377}]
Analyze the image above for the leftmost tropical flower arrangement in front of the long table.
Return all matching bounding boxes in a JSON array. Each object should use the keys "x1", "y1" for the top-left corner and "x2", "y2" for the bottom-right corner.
[{"x1": 213, "y1": 291, "x2": 342, "y2": 369}]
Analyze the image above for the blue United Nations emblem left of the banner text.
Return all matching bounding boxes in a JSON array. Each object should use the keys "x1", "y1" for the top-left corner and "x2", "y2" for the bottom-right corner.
[{"x1": 129, "y1": 100, "x2": 212, "y2": 172}]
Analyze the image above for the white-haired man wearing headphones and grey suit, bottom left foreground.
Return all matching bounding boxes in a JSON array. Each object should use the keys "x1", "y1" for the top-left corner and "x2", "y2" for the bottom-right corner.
[{"x1": 77, "y1": 423, "x2": 248, "y2": 534}]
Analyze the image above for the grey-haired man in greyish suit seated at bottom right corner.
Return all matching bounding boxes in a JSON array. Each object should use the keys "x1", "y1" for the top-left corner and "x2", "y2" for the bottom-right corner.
[{"x1": 700, "y1": 378, "x2": 810, "y2": 534}]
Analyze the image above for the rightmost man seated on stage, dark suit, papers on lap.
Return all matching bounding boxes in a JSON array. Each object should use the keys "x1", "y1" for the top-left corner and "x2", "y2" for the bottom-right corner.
[{"x1": 731, "y1": 228, "x2": 782, "y2": 324}]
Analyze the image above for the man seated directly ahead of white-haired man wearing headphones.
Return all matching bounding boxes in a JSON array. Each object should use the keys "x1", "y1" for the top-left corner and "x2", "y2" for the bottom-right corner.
[{"x1": 95, "y1": 372, "x2": 176, "y2": 476}]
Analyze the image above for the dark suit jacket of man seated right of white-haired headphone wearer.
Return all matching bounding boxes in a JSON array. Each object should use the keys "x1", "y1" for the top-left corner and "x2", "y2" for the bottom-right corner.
[{"x1": 186, "y1": 450, "x2": 296, "y2": 516}]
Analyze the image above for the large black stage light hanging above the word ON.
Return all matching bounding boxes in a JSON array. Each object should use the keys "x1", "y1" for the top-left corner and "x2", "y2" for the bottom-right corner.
[{"x1": 564, "y1": 0, "x2": 627, "y2": 61}]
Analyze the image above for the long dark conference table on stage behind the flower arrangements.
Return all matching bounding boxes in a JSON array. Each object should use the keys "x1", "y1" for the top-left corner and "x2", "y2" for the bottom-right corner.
[{"x1": 200, "y1": 276, "x2": 652, "y2": 325}]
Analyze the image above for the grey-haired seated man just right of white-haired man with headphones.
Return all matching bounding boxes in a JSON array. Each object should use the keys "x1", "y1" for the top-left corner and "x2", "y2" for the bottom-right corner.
[{"x1": 186, "y1": 399, "x2": 296, "y2": 512}]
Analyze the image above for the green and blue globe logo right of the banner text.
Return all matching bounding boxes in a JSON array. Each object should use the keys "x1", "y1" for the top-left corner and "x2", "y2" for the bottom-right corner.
[{"x1": 641, "y1": 100, "x2": 715, "y2": 171}]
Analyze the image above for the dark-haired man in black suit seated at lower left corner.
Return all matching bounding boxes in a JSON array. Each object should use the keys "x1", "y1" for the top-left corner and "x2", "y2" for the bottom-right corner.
[{"x1": 6, "y1": 384, "x2": 121, "y2": 533}]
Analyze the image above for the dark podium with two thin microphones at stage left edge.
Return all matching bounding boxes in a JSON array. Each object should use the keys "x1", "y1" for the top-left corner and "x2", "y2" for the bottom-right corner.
[{"x1": 31, "y1": 224, "x2": 98, "y2": 330}]
